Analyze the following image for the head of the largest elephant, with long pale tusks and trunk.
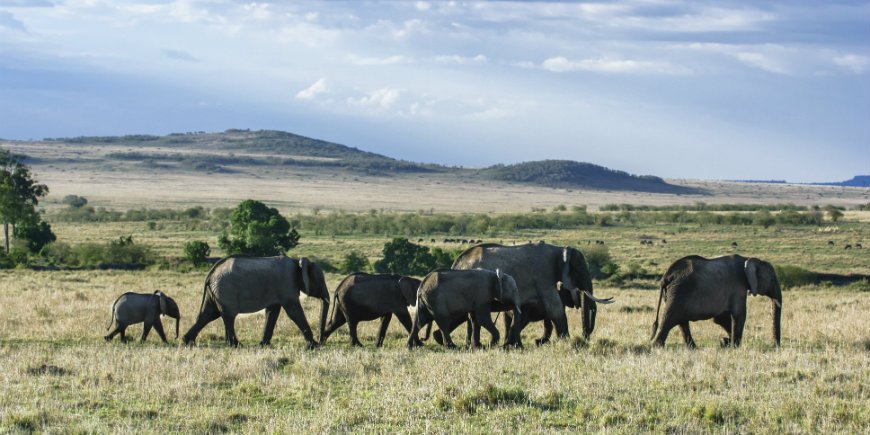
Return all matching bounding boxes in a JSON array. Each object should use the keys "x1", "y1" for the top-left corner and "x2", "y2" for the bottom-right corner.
[{"x1": 560, "y1": 247, "x2": 613, "y2": 338}]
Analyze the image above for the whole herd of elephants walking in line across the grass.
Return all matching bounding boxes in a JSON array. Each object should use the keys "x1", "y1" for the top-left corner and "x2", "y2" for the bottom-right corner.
[{"x1": 104, "y1": 243, "x2": 782, "y2": 348}]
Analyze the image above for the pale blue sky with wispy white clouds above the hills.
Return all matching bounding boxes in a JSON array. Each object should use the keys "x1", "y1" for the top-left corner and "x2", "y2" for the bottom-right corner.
[{"x1": 0, "y1": 0, "x2": 870, "y2": 182}]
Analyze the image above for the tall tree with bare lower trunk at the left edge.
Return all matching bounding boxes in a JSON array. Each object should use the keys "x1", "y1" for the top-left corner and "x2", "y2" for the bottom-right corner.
[{"x1": 0, "y1": 149, "x2": 50, "y2": 254}]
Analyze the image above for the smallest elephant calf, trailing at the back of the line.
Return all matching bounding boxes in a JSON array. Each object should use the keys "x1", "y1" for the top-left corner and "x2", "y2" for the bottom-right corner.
[{"x1": 103, "y1": 290, "x2": 181, "y2": 343}]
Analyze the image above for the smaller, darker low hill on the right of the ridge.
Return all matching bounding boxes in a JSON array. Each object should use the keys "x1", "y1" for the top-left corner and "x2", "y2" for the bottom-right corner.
[{"x1": 478, "y1": 160, "x2": 699, "y2": 193}]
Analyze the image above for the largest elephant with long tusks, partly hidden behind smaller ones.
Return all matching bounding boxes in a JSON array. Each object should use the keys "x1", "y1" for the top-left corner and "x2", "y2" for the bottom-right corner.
[{"x1": 446, "y1": 243, "x2": 613, "y2": 346}]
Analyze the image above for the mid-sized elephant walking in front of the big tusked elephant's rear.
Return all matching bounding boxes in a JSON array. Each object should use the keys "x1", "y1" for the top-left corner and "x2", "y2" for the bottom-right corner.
[{"x1": 408, "y1": 269, "x2": 522, "y2": 348}]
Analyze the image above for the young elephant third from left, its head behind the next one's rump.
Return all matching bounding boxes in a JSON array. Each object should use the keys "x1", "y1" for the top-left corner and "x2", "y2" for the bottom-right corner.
[{"x1": 320, "y1": 273, "x2": 420, "y2": 347}]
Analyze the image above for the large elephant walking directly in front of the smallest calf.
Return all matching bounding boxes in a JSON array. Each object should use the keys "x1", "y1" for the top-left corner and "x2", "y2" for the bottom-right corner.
[{"x1": 184, "y1": 255, "x2": 329, "y2": 348}]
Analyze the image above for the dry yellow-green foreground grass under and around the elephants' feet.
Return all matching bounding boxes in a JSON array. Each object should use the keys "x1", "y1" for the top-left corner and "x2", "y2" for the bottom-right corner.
[{"x1": 0, "y1": 270, "x2": 870, "y2": 433}]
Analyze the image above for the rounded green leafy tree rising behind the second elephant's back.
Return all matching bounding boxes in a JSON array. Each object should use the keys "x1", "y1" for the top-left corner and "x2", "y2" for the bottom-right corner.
[{"x1": 218, "y1": 199, "x2": 299, "y2": 256}]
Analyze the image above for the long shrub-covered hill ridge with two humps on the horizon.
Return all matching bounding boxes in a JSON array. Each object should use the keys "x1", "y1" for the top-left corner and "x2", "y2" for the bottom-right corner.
[{"x1": 34, "y1": 129, "x2": 703, "y2": 194}]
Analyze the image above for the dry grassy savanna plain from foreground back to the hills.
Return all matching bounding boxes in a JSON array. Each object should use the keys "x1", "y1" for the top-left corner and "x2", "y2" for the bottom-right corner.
[{"x1": 0, "y1": 146, "x2": 870, "y2": 434}]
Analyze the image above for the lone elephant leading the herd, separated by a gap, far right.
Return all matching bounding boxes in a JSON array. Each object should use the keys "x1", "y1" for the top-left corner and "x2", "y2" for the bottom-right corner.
[{"x1": 653, "y1": 255, "x2": 782, "y2": 348}]
